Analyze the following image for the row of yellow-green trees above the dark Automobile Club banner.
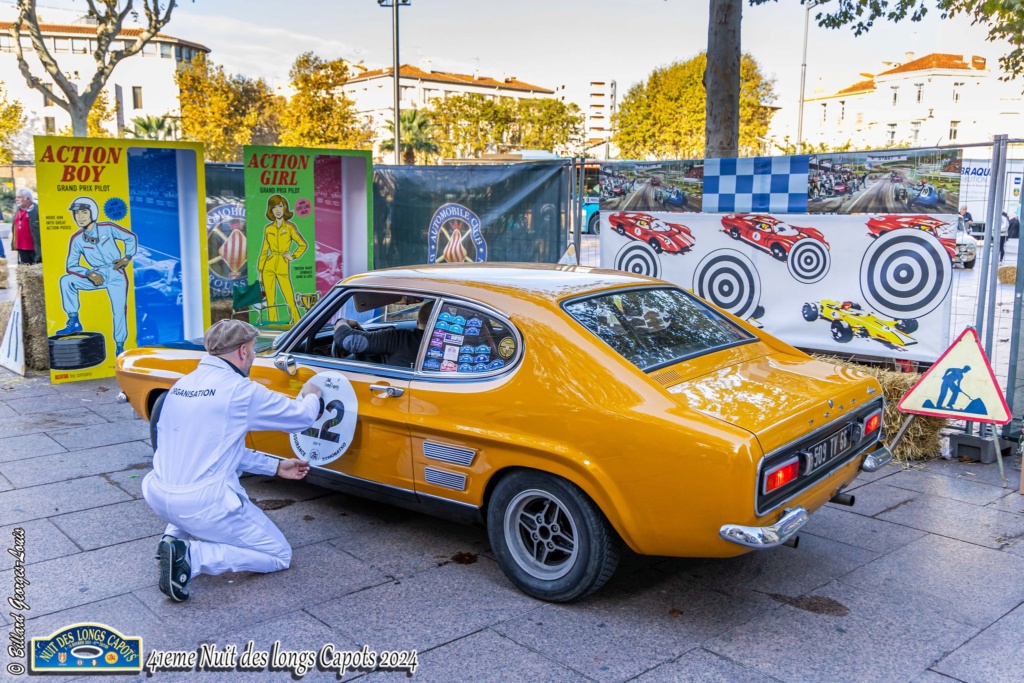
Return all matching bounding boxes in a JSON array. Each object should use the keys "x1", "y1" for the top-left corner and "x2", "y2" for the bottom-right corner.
[{"x1": 427, "y1": 93, "x2": 583, "y2": 158}]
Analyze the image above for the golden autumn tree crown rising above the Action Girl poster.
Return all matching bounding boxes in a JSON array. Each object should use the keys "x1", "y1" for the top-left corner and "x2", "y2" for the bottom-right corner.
[{"x1": 281, "y1": 52, "x2": 373, "y2": 150}]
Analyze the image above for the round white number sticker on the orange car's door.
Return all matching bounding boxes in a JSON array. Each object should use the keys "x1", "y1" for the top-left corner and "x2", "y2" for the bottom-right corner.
[{"x1": 290, "y1": 372, "x2": 359, "y2": 466}]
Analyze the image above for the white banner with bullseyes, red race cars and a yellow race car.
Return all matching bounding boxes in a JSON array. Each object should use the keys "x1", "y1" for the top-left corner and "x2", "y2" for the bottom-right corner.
[{"x1": 601, "y1": 211, "x2": 957, "y2": 361}]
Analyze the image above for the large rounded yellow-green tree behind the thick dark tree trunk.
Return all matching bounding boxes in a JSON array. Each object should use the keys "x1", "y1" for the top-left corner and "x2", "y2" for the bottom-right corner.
[{"x1": 613, "y1": 52, "x2": 775, "y2": 159}]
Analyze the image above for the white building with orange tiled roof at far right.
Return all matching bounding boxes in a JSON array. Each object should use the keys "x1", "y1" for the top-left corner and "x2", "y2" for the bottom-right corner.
[{"x1": 804, "y1": 53, "x2": 1024, "y2": 150}]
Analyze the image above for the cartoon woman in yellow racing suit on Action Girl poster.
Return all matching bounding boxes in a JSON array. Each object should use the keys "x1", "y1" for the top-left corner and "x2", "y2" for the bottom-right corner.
[{"x1": 256, "y1": 195, "x2": 308, "y2": 323}]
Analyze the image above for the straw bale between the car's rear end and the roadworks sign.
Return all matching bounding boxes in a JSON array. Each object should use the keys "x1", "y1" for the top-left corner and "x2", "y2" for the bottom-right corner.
[{"x1": 815, "y1": 355, "x2": 948, "y2": 462}]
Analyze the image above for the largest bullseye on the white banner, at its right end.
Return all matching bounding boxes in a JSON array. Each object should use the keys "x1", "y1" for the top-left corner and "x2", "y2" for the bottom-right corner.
[{"x1": 860, "y1": 228, "x2": 953, "y2": 318}]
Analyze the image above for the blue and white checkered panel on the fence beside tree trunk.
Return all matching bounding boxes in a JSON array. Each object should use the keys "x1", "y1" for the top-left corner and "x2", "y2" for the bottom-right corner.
[{"x1": 702, "y1": 155, "x2": 810, "y2": 213}]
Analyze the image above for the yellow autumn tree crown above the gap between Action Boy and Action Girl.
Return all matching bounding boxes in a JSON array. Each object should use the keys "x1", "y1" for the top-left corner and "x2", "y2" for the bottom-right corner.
[{"x1": 174, "y1": 54, "x2": 282, "y2": 162}]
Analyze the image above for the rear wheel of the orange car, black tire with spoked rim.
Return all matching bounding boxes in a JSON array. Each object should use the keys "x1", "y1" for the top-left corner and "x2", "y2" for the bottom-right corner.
[{"x1": 487, "y1": 470, "x2": 621, "y2": 602}]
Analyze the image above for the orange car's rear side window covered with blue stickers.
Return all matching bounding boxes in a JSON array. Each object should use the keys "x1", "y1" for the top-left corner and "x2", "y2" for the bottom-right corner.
[{"x1": 418, "y1": 301, "x2": 519, "y2": 376}]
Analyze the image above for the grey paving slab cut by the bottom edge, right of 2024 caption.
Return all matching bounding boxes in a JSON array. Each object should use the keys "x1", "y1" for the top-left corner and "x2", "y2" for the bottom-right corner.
[{"x1": 360, "y1": 629, "x2": 590, "y2": 683}]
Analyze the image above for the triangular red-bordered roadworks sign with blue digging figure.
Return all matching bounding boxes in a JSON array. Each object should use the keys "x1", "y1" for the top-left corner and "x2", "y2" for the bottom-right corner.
[{"x1": 897, "y1": 328, "x2": 1010, "y2": 425}]
